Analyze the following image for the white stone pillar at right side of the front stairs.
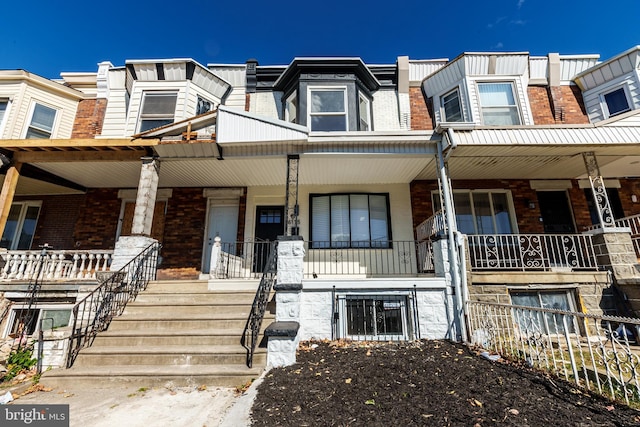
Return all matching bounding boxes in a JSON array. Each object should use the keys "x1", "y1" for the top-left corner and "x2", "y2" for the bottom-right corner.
[{"x1": 265, "y1": 236, "x2": 304, "y2": 367}]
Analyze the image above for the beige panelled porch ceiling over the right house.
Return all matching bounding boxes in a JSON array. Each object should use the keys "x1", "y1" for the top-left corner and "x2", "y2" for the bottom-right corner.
[{"x1": 418, "y1": 144, "x2": 640, "y2": 180}]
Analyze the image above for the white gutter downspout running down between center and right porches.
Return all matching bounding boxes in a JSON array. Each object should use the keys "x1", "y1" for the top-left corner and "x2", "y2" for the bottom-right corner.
[{"x1": 438, "y1": 129, "x2": 467, "y2": 341}]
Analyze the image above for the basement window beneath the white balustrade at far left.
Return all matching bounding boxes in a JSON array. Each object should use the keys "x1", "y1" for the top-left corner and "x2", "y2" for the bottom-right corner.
[{"x1": 5, "y1": 304, "x2": 73, "y2": 337}]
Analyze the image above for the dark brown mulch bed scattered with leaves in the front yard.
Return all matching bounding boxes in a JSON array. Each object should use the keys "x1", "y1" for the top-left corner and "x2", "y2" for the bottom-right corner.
[{"x1": 252, "y1": 341, "x2": 640, "y2": 427}]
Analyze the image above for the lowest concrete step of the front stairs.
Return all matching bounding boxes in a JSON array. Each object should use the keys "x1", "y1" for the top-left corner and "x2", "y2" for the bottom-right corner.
[{"x1": 40, "y1": 363, "x2": 264, "y2": 388}]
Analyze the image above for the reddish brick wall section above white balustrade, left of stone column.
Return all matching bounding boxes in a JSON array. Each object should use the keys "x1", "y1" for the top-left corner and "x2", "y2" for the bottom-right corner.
[{"x1": 73, "y1": 188, "x2": 122, "y2": 249}]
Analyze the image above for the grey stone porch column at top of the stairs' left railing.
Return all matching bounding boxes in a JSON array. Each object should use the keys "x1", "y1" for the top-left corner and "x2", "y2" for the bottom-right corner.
[{"x1": 131, "y1": 157, "x2": 160, "y2": 236}]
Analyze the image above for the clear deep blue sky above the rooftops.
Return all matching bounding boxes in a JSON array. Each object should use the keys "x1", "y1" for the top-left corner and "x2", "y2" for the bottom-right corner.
[{"x1": 0, "y1": 0, "x2": 640, "y2": 78}]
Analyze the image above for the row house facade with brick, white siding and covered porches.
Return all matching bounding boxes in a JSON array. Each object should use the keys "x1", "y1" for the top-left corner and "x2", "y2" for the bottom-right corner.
[{"x1": 0, "y1": 47, "x2": 640, "y2": 372}]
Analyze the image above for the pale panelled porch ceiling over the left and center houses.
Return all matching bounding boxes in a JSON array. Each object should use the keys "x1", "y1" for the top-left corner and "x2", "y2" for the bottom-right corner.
[{"x1": 21, "y1": 153, "x2": 434, "y2": 189}]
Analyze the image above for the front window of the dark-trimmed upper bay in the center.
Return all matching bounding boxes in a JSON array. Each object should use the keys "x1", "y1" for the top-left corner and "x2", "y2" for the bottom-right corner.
[{"x1": 307, "y1": 87, "x2": 348, "y2": 132}]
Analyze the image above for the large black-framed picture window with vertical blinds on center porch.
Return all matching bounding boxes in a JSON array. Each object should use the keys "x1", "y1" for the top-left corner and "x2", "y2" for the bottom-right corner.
[{"x1": 311, "y1": 194, "x2": 390, "y2": 248}]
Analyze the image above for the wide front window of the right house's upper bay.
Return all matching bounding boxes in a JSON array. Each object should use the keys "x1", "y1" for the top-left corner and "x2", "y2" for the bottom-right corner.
[{"x1": 478, "y1": 82, "x2": 520, "y2": 126}]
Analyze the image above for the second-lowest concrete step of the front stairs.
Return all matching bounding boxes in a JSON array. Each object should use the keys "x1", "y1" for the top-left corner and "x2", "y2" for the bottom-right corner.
[{"x1": 73, "y1": 343, "x2": 266, "y2": 367}]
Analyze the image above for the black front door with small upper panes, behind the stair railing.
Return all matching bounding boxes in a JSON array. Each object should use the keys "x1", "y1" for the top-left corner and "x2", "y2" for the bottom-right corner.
[{"x1": 253, "y1": 206, "x2": 284, "y2": 273}]
